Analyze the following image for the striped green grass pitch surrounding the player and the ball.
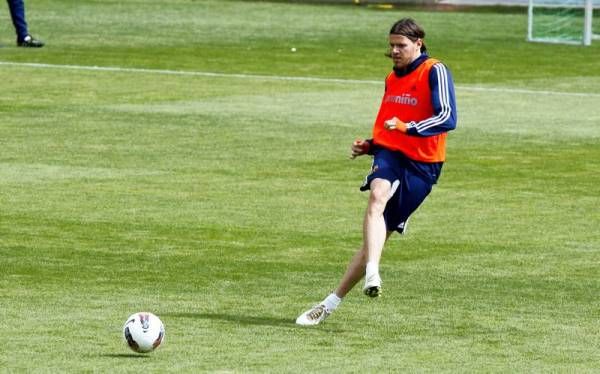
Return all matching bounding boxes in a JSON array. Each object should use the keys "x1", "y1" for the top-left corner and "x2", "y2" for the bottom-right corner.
[{"x1": 0, "y1": 0, "x2": 600, "y2": 373}]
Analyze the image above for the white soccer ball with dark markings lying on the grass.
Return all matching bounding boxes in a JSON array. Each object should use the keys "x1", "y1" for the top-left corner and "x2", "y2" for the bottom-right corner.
[{"x1": 123, "y1": 312, "x2": 165, "y2": 353}]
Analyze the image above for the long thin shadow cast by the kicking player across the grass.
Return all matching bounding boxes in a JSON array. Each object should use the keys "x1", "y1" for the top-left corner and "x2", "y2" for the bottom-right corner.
[{"x1": 161, "y1": 313, "x2": 342, "y2": 332}]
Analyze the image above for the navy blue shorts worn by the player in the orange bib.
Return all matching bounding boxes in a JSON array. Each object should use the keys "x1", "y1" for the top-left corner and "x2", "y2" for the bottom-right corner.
[{"x1": 360, "y1": 149, "x2": 435, "y2": 234}]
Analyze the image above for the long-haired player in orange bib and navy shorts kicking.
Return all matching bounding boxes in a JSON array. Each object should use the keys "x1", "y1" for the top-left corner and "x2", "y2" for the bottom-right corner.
[{"x1": 296, "y1": 18, "x2": 457, "y2": 326}]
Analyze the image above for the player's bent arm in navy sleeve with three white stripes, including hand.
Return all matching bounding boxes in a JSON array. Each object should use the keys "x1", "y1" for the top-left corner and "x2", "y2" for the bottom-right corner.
[{"x1": 397, "y1": 63, "x2": 457, "y2": 136}]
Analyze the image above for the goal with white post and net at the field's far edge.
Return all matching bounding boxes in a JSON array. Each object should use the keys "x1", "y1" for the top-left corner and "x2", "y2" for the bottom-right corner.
[{"x1": 527, "y1": 0, "x2": 600, "y2": 45}]
